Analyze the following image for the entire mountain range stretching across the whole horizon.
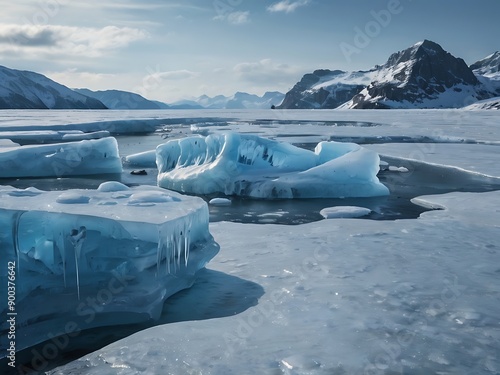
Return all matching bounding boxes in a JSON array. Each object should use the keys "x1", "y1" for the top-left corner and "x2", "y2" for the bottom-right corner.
[{"x1": 0, "y1": 40, "x2": 500, "y2": 110}]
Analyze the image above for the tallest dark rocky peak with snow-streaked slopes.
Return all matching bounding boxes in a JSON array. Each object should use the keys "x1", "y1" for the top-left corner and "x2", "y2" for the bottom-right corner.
[{"x1": 348, "y1": 40, "x2": 487, "y2": 109}]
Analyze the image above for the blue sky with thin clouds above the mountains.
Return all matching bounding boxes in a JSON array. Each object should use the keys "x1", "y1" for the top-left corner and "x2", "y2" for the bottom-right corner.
[{"x1": 0, "y1": 0, "x2": 500, "y2": 103}]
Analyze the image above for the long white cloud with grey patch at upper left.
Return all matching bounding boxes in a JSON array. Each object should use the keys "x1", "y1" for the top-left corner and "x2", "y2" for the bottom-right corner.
[{"x1": 0, "y1": 24, "x2": 148, "y2": 57}]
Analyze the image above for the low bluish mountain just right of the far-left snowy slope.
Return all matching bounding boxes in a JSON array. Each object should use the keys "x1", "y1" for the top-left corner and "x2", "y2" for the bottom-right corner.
[{"x1": 75, "y1": 89, "x2": 168, "y2": 109}]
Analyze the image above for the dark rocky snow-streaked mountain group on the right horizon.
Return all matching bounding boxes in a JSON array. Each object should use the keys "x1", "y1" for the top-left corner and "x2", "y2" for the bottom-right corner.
[{"x1": 278, "y1": 40, "x2": 500, "y2": 109}]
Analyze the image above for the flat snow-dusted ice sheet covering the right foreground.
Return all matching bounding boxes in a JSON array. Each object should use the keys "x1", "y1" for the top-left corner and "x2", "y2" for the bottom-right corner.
[{"x1": 50, "y1": 192, "x2": 500, "y2": 375}]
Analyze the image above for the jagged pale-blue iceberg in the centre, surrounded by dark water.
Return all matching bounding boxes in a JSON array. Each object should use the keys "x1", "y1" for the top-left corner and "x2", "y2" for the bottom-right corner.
[{"x1": 156, "y1": 132, "x2": 389, "y2": 199}]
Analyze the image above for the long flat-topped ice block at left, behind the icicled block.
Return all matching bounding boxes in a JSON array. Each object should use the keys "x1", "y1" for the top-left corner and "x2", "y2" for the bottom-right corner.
[{"x1": 0, "y1": 137, "x2": 122, "y2": 178}]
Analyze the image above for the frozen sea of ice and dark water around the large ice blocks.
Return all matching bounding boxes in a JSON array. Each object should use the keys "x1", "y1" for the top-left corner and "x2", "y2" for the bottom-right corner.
[{"x1": 0, "y1": 110, "x2": 500, "y2": 374}]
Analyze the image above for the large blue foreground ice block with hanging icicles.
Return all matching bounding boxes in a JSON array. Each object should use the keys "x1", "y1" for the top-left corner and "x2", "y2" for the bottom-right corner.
[{"x1": 0, "y1": 182, "x2": 219, "y2": 350}]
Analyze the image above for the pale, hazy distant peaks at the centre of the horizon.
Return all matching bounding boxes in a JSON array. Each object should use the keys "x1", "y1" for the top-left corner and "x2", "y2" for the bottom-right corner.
[{"x1": 171, "y1": 91, "x2": 285, "y2": 109}]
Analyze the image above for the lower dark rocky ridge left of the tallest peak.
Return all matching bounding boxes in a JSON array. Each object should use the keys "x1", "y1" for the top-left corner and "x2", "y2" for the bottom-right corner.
[{"x1": 277, "y1": 69, "x2": 365, "y2": 109}]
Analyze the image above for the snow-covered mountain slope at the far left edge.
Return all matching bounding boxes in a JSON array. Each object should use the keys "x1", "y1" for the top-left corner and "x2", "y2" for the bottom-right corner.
[{"x1": 0, "y1": 66, "x2": 106, "y2": 109}]
